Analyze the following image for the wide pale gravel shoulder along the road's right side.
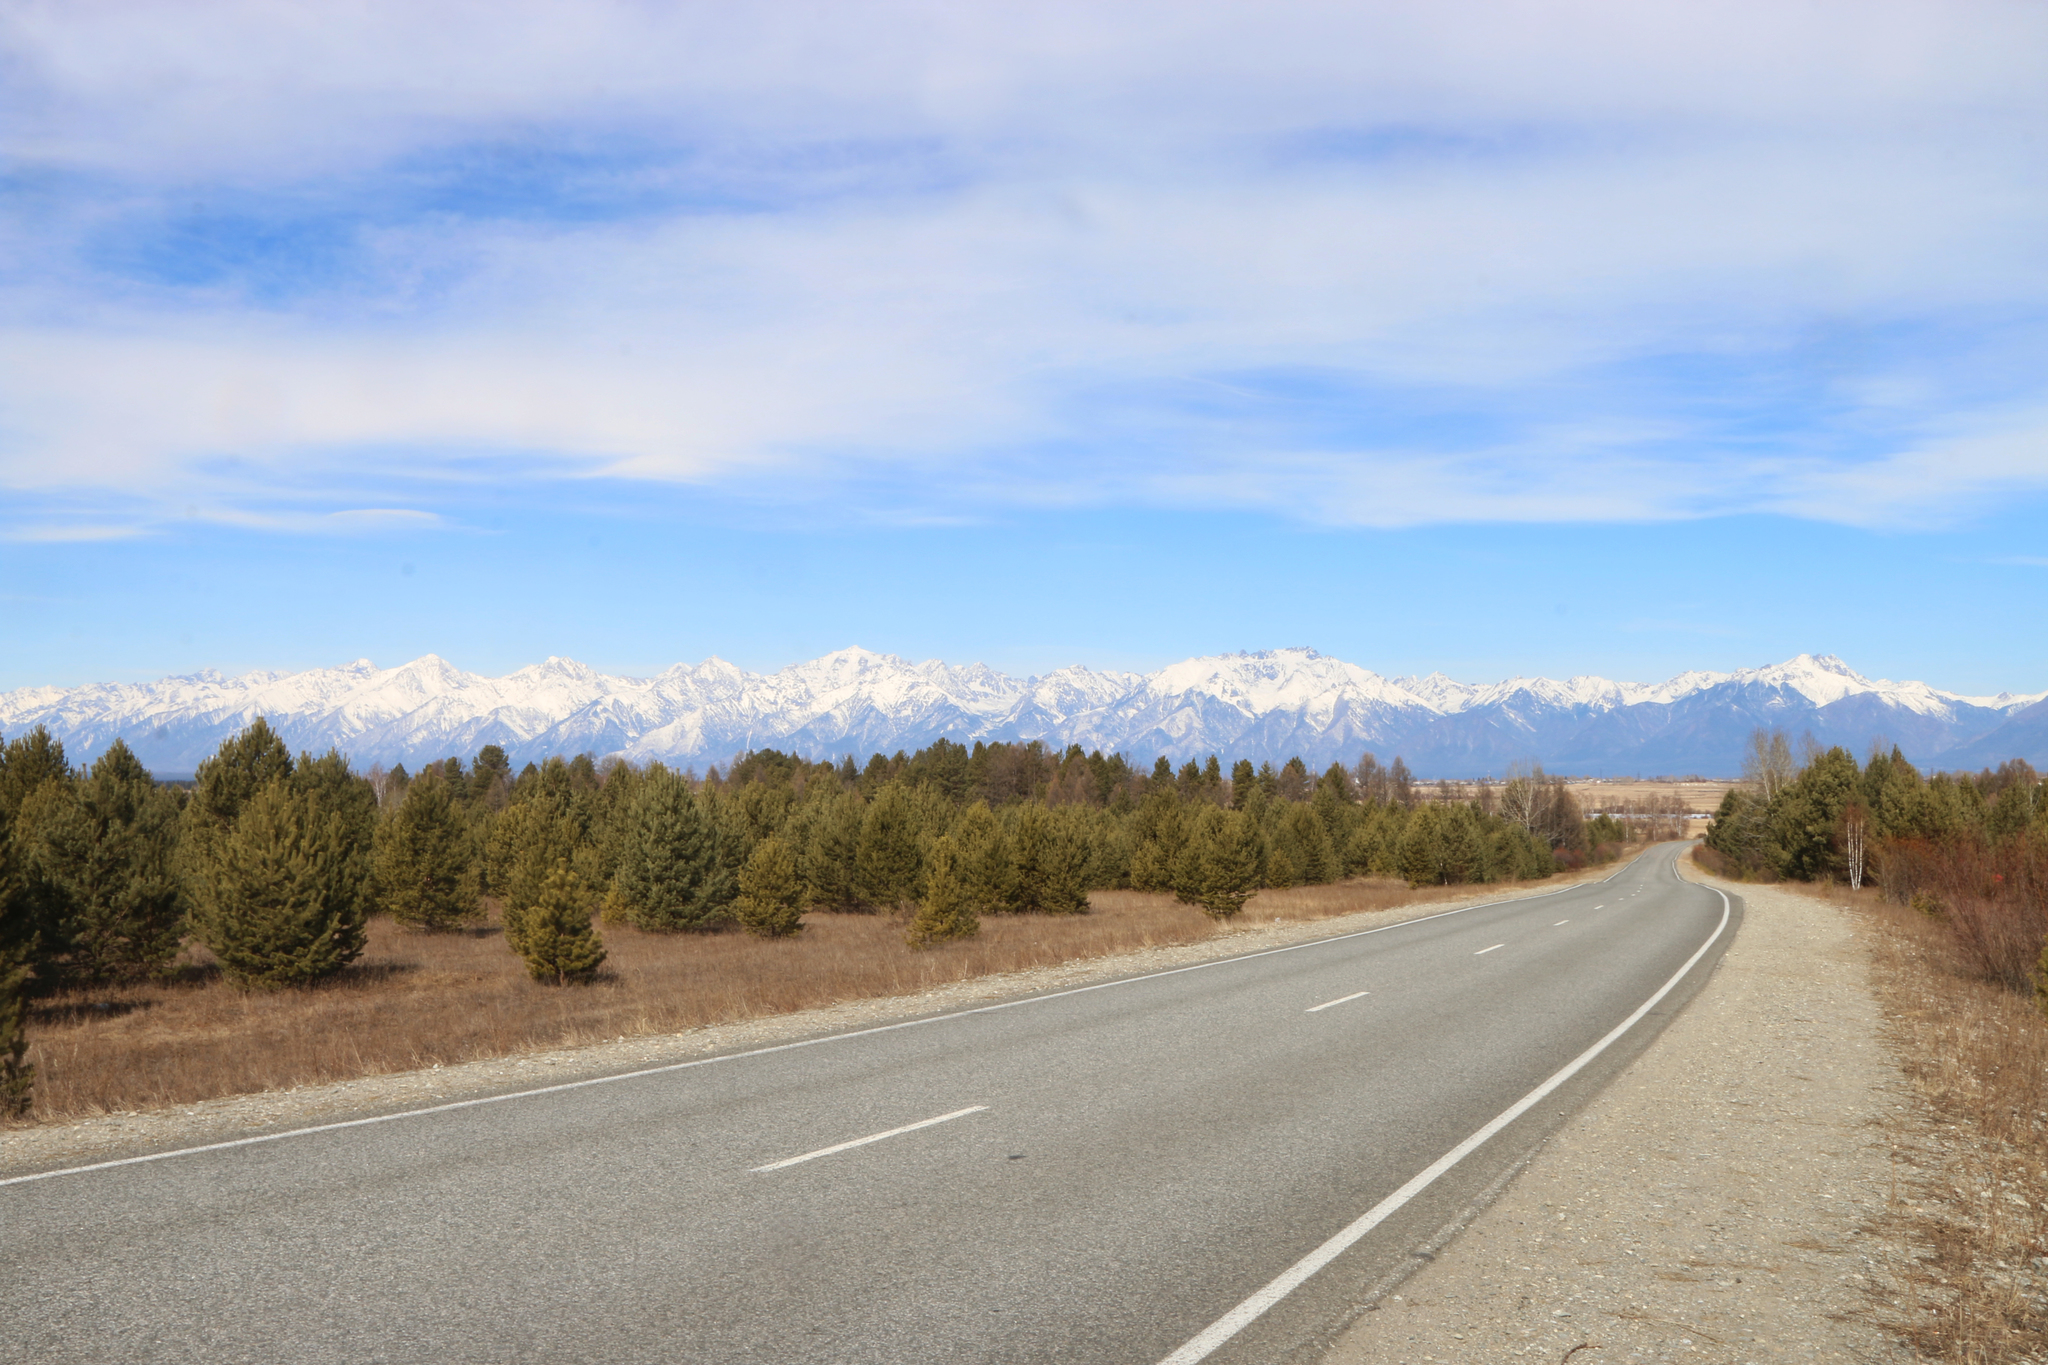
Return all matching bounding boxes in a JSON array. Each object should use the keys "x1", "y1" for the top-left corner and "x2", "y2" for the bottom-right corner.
[{"x1": 1325, "y1": 864, "x2": 1913, "y2": 1365}]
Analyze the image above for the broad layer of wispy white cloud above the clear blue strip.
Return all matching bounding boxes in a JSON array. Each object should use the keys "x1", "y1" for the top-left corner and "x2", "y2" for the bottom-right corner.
[{"x1": 0, "y1": 4, "x2": 2048, "y2": 530}]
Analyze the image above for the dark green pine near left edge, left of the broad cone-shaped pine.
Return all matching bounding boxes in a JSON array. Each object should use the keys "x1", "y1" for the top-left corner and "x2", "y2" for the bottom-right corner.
[{"x1": 16, "y1": 739, "x2": 184, "y2": 988}]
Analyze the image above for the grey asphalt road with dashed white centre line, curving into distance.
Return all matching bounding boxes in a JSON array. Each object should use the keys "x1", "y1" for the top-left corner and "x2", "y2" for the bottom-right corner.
[{"x1": 0, "y1": 847, "x2": 1735, "y2": 1365}]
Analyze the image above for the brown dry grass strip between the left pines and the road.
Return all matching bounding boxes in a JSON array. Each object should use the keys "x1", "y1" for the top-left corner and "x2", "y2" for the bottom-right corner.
[{"x1": 16, "y1": 880, "x2": 1479, "y2": 1121}]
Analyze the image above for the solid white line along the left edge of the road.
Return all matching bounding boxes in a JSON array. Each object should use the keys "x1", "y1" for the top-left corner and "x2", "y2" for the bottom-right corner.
[{"x1": 0, "y1": 853, "x2": 1647, "y2": 1187}]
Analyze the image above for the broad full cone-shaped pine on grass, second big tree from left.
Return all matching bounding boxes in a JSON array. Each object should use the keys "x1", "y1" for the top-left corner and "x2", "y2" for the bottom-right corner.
[{"x1": 193, "y1": 778, "x2": 362, "y2": 986}]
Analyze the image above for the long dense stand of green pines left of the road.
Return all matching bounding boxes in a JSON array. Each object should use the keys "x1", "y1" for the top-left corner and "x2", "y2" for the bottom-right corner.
[{"x1": 0, "y1": 720, "x2": 1624, "y2": 1107}]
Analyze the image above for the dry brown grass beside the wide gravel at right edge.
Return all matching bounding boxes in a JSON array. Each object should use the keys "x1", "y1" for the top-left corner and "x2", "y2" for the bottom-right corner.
[{"x1": 1769, "y1": 871, "x2": 2048, "y2": 1365}]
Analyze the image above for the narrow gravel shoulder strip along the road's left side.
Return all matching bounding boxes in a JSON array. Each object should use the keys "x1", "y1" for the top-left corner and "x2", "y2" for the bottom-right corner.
[{"x1": 0, "y1": 868, "x2": 1614, "y2": 1177}]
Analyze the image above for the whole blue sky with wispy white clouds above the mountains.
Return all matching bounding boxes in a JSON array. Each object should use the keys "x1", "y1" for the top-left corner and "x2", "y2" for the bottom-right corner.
[{"x1": 0, "y1": 0, "x2": 2048, "y2": 694}]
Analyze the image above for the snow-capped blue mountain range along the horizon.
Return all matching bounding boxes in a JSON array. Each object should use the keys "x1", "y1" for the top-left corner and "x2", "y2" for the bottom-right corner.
[{"x1": 0, "y1": 649, "x2": 2048, "y2": 778}]
